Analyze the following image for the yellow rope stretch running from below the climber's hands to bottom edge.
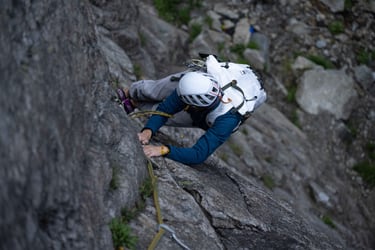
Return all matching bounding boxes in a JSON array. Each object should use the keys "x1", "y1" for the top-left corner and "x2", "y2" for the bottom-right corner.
[{"x1": 147, "y1": 159, "x2": 165, "y2": 250}]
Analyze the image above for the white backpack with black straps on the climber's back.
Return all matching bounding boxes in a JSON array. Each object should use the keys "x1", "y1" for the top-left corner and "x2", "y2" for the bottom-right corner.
[{"x1": 205, "y1": 55, "x2": 267, "y2": 126}]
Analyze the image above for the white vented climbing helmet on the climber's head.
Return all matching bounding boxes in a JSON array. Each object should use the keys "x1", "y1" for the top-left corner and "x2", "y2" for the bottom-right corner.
[{"x1": 177, "y1": 72, "x2": 220, "y2": 107}]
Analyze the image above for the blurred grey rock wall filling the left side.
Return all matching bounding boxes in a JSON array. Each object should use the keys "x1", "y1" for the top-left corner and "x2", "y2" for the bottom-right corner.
[{"x1": 0, "y1": 1, "x2": 146, "y2": 249}]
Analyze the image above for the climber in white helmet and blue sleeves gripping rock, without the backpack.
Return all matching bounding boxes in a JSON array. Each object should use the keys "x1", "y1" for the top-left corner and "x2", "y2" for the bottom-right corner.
[{"x1": 117, "y1": 54, "x2": 264, "y2": 165}]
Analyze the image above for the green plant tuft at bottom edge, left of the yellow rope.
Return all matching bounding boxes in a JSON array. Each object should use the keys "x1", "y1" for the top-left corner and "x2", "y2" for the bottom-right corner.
[{"x1": 109, "y1": 218, "x2": 138, "y2": 249}]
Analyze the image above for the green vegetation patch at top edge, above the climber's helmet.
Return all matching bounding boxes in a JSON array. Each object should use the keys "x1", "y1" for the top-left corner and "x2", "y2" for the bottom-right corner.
[{"x1": 154, "y1": 0, "x2": 202, "y2": 25}]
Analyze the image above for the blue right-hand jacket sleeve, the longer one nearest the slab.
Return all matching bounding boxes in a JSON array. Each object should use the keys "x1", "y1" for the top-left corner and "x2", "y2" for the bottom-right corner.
[{"x1": 166, "y1": 112, "x2": 241, "y2": 165}]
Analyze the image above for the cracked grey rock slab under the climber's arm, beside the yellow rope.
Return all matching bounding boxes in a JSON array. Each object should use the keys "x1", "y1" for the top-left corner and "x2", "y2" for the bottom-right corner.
[{"x1": 132, "y1": 158, "x2": 343, "y2": 249}]
